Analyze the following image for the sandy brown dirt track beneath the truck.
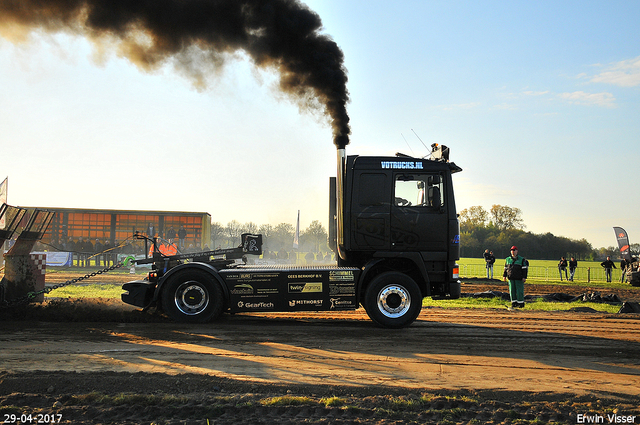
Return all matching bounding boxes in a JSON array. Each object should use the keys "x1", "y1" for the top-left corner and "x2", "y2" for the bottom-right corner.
[{"x1": 0, "y1": 274, "x2": 640, "y2": 424}]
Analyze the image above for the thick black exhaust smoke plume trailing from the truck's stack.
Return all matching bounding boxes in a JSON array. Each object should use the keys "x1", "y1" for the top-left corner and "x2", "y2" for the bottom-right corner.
[{"x1": 0, "y1": 0, "x2": 350, "y2": 149}]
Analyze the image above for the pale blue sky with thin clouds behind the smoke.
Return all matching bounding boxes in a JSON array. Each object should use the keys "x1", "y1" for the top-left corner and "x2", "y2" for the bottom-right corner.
[{"x1": 0, "y1": 0, "x2": 640, "y2": 248}]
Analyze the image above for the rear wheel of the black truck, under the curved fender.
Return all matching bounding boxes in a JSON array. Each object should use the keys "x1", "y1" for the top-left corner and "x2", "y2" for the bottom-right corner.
[{"x1": 162, "y1": 270, "x2": 224, "y2": 323}]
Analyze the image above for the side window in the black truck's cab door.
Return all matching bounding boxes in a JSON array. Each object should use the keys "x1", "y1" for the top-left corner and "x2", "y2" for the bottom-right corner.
[{"x1": 394, "y1": 174, "x2": 444, "y2": 208}]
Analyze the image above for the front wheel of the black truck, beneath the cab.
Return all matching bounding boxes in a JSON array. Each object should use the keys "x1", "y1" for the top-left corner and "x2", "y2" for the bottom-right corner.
[{"x1": 364, "y1": 272, "x2": 422, "y2": 329}]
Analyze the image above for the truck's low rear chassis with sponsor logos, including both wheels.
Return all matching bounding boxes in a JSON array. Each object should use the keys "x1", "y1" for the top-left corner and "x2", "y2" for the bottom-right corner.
[{"x1": 122, "y1": 234, "x2": 422, "y2": 328}]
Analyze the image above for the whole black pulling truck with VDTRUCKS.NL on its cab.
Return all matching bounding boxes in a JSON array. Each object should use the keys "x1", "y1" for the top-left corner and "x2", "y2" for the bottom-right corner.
[{"x1": 122, "y1": 145, "x2": 461, "y2": 328}]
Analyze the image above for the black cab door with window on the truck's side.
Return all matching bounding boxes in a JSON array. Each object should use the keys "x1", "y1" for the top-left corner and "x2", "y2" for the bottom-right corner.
[{"x1": 390, "y1": 172, "x2": 449, "y2": 252}]
